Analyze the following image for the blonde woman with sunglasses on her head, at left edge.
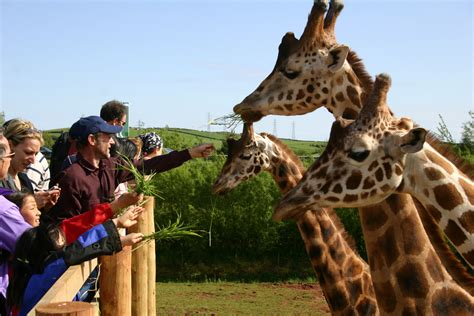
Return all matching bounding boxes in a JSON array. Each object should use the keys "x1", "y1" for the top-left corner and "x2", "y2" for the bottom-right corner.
[{"x1": 0, "y1": 119, "x2": 60, "y2": 209}]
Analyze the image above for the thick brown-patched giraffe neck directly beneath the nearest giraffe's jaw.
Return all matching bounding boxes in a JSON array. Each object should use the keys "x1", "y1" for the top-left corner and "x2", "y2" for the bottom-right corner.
[{"x1": 359, "y1": 194, "x2": 474, "y2": 315}]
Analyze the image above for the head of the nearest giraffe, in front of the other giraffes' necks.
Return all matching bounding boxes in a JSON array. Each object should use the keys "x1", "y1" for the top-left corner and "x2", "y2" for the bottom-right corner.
[{"x1": 274, "y1": 74, "x2": 427, "y2": 220}]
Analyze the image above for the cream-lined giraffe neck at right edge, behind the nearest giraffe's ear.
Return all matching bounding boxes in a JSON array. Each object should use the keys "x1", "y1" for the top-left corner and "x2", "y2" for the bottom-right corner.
[{"x1": 400, "y1": 144, "x2": 474, "y2": 269}]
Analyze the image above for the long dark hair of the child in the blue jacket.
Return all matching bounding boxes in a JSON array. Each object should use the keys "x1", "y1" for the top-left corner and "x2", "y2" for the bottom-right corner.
[{"x1": 7, "y1": 225, "x2": 62, "y2": 307}]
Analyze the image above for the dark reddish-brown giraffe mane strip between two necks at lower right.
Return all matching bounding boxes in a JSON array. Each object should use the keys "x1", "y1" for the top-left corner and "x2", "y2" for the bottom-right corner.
[{"x1": 413, "y1": 197, "x2": 474, "y2": 295}]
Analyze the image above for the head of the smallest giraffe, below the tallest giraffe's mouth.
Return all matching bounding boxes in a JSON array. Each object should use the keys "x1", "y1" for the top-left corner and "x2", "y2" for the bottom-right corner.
[{"x1": 212, "y1": 123, "x2": 270, "y2": 194}]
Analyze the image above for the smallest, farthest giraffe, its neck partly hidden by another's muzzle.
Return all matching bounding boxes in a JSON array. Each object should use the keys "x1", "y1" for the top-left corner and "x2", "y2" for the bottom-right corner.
[{"x1": 213, "y1": 124, "x2": 379, "y2": 315}]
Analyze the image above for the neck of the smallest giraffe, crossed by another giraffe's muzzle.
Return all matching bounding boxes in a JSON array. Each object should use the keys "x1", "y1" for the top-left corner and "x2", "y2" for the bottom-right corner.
[{"x1": 267, "y1": 135, "x2": 379, "y2": 315}]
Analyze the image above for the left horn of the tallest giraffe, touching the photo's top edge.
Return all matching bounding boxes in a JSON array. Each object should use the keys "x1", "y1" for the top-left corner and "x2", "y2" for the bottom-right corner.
[{"x1": 301, "y1": 0, "x2": 328, "y2": 46}]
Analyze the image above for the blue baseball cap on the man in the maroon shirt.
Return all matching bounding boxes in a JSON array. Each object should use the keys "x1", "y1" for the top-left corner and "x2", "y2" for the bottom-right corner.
[{"x1": 69, "y1": 115, "x2": 122, "y2": 140}]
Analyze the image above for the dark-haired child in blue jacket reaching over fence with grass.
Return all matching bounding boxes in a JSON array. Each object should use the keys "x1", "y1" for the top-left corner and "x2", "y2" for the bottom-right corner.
[{"x1": 7, "y1": 202, "x2": 143, "y2": 315}]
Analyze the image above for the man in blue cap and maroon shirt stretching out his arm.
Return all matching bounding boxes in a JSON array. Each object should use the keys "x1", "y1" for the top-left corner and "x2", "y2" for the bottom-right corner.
[{"x1": 44, "y1": 116, "x2": 214, "y2": 223}]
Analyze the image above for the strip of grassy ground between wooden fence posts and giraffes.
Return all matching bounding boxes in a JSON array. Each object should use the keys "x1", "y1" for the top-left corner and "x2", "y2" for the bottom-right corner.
[{"x1": 156, "y1": 282, "x2": 330, "y2": 315}]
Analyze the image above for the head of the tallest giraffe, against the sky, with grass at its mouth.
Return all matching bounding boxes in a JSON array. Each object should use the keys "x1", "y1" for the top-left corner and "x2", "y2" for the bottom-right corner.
[{"x1": 234, "y1": 0, "x2": 371, "y2": 122}]
